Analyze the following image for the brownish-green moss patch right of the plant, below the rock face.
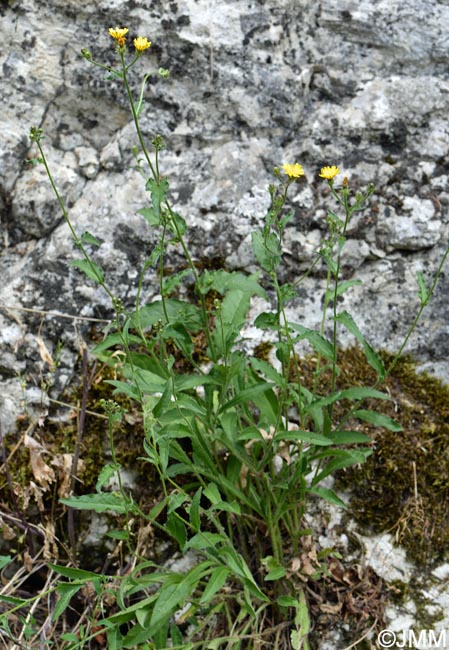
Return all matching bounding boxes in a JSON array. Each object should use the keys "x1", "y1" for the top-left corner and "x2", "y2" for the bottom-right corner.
[{"x1": 318, "y1": 348, "x2": 449, "y2": 563}]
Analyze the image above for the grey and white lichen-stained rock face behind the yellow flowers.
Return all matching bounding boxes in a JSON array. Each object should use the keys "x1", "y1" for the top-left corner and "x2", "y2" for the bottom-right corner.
[{"x1": 0, "y1": 0, "x2": 449, "y2": 431}]
